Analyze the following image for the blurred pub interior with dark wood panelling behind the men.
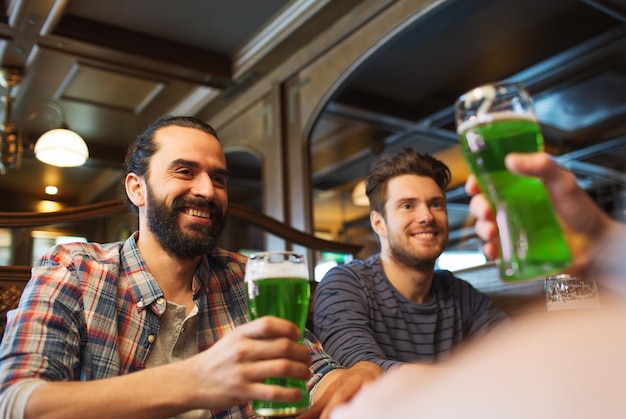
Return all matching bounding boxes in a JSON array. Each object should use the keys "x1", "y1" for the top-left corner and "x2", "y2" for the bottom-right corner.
[{"x1": 0, "y1": 0, "x2": 626, "y2": 316}]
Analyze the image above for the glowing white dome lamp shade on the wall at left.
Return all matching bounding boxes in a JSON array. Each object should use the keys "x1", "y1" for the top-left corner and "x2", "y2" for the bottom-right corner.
[{"x1": 35, "y1": 128, "x2": 89, "y2": 167}]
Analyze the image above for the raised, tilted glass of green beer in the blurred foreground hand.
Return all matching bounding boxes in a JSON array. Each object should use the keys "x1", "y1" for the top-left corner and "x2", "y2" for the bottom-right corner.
[{"x1": 455, "y1": 82, "x2": 571, "y2": 281}]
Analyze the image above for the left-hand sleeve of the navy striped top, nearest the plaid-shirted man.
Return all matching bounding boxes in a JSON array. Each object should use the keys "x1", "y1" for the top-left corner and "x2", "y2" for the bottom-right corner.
[{"x1": 314, "y1": 267, "x2": 403, "y2": 370}]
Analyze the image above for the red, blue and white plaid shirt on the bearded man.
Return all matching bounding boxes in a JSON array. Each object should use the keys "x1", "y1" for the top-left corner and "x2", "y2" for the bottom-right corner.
[{"x1": 0, "y1": 233, "x2": 340, "y2": 418}]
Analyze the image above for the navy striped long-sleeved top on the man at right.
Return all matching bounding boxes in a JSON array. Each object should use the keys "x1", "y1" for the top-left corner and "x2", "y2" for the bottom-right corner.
[{"x1": 314, "y1": 254, "x2": 506, "y2": 369}]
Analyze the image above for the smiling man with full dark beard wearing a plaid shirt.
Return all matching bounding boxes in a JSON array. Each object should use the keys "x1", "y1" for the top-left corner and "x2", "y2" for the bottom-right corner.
[{"x1": 0, "y1": 116, "x2": 382, "y2": 419}]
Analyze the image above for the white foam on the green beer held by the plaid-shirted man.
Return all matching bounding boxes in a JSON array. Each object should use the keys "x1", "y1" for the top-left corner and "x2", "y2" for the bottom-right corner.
[{"x1": 245, "y1": 252, "x2": 309, "y2": 281}]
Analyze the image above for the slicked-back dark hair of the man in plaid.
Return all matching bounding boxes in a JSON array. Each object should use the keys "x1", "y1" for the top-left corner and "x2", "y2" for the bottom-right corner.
[{"x1": 124, "y1": 115, "x2": 219, "y2": 212}]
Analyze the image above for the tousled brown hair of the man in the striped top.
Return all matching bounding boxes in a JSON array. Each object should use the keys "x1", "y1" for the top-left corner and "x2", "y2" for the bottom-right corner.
[{"x1": 365, "y1": 148, "x2": 451, "y2": 217}]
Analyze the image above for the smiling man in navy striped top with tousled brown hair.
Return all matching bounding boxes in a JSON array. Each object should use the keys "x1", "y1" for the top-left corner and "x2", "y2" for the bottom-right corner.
[{"x1": 314, "y1": 148, "x2": 506, "y2": 370}]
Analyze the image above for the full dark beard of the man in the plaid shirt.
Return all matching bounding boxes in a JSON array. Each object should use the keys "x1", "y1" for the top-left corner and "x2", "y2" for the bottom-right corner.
[{"x1": 147, "y1": 187, "x2": 227, "y2": 259}]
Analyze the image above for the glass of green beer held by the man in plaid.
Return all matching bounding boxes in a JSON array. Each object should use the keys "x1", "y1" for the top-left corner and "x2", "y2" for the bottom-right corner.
[{"x1": 245, "y1": 251, "x2": 310, "y2": 417}]
